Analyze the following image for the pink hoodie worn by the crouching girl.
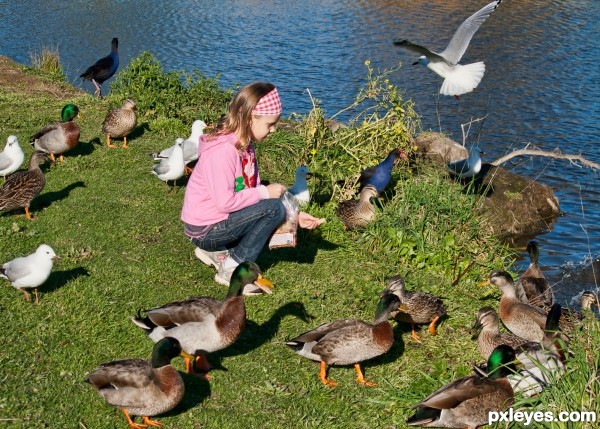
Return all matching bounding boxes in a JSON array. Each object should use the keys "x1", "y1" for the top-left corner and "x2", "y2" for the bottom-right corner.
[{"x1": 181, "y1": 134, "x2": 269, "y2": 226}]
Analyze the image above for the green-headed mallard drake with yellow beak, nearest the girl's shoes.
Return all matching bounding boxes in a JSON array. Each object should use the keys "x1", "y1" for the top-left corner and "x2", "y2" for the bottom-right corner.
[{"x1": 131, "y1": 262, "x2": 273, "y2": 374}]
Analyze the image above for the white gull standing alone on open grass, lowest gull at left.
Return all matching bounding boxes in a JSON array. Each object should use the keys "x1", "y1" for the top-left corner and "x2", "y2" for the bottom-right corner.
[{"x1": 0, "y1": 244, "x2": 58, "y2": 305}]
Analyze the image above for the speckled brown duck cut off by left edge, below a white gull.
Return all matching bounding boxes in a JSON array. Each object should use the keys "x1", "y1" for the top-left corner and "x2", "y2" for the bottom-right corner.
[{"x1": 0, "y1": 152, "x2": 49, "y2": 219}]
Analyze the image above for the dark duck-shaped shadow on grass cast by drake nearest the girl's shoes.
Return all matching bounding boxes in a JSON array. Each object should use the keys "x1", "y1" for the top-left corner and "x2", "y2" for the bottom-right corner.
[{"x1": 209, "y1": 301, "x2": 313, "y2": 370}]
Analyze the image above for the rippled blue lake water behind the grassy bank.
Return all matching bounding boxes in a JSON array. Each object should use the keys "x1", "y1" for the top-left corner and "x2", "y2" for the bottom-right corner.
[{"x1": 0, "y1": 0, "x2": 600, "y2": 304}]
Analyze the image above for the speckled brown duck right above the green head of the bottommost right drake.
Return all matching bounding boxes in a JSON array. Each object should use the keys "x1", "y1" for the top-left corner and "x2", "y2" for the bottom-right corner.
[{"x1": 472, "y1": 307, "x2": 537, "y2": 359}]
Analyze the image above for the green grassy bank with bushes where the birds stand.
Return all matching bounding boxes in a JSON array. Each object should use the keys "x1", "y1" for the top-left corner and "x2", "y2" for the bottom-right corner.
[{"x1": 0, "y1": 57, "x2": 600, "y2": 429}]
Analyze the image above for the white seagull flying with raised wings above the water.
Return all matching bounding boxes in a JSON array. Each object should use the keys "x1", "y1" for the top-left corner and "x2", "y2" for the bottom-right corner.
[{"x1": 394, "y1": 0, "x2": 502, "y2": 98}]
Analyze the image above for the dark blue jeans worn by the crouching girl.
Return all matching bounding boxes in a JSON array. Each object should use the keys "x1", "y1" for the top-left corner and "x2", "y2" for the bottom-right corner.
[{"x1": 191, "y1": 198, "x2": 285, "y2": 263}]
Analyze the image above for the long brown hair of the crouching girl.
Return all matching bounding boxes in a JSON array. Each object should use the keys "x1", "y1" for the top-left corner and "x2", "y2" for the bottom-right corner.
[{"x1": 209, "y1": 82, "x2": 275, "y2": 150}]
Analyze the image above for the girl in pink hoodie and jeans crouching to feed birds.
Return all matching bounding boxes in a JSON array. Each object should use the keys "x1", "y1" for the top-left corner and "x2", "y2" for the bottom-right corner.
[{"x1": 181, "y1": 82, "x2": 325, "y2": 285}]
